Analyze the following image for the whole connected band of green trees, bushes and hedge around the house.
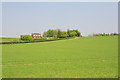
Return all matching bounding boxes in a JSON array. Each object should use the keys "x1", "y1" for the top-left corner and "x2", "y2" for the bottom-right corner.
[{"x1": 20, "y1": 29, "x2": 82, "y2": 42}]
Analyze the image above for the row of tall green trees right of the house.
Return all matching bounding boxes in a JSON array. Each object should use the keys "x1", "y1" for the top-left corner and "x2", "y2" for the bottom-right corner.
[{"x1": 43, "y1": 29, "x2": 81, "y2": 38}]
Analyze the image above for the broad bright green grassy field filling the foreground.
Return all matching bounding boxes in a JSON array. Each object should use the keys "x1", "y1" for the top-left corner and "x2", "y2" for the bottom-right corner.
[{"x1": 2, "y1": 36, "x2": 118, "y2": 78}]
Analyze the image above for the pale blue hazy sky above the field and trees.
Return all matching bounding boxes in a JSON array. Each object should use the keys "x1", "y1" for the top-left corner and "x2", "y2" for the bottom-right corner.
[{"x1": 2, "y1": 2, "x2": 118, "y2": 37}]
